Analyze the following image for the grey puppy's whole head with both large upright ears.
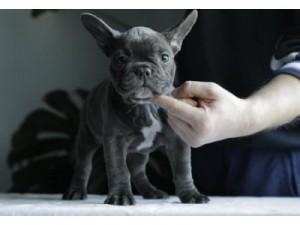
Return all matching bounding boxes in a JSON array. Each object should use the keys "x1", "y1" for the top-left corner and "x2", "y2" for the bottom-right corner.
[{"x1": 81, "y1": 10, "x2": 197, "y2": 104}]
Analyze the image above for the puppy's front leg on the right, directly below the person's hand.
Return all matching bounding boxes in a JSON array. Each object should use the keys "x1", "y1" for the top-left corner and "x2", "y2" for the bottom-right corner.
[{"x1": 167, "y1": 138, "x2": 209, "y2": 203}]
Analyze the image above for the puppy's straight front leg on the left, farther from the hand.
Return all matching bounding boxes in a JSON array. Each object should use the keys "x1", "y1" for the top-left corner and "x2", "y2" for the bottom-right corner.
[{"x1": 104, "y1": 137, "x2": 135, "y2": 205}]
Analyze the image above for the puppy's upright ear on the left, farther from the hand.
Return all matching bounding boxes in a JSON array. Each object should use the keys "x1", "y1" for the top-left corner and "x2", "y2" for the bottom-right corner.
[{"x1": 81, "y1": 13, "x2": 120, "y2": 56}]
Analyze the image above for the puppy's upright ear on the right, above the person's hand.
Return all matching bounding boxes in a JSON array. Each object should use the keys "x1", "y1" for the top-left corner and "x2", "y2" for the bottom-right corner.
[{"x1": 163, "y1": 10, "x2": 198, "y2": 54}]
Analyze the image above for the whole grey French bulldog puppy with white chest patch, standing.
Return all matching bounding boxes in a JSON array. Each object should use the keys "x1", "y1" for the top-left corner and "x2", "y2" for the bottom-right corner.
[{"x1": 63, "y1": 10, "x2": 209, "y2": 205}]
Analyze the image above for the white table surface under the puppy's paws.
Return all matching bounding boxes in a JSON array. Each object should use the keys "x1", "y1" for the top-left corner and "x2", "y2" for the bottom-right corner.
[{"x1": 0, "y1": 194, "x2": 300, "y2": 216}]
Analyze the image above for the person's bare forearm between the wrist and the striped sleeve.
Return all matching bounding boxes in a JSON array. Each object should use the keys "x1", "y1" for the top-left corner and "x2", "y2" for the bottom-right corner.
[{"x1": 246, "y1": 75, "x2": 300, "y2": 134}]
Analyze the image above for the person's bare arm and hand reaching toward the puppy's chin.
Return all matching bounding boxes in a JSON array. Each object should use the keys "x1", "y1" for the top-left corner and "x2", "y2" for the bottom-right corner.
[{"x1": 153, "y1": 75, "x2": 300, "y2": 147}]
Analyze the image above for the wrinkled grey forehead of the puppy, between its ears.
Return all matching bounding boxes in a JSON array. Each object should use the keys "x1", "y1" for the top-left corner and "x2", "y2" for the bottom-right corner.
[{"x1": 118, "y1": 27, "x2": 172, "y2": 56}]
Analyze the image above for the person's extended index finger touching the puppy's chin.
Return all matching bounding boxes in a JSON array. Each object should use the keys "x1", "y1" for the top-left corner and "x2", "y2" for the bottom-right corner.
[{"x1": 152, "y1": 95, "x2": 201, "y2": 123}]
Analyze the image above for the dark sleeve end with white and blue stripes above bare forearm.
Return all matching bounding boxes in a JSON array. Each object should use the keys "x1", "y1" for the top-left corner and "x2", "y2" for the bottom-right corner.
[{"x1": 270, "y1": 27, "x2": 300, "y2": 79}]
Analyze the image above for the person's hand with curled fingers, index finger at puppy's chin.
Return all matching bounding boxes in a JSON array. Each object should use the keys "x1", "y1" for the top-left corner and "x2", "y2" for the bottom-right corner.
[{"x1": 153, "y1": 81, "x2": 254, "y2": 147}]
